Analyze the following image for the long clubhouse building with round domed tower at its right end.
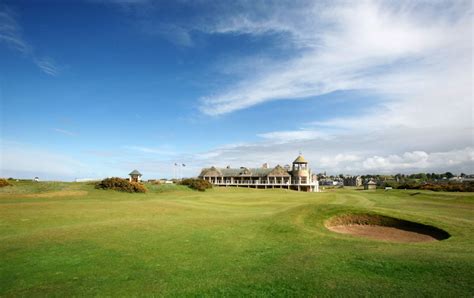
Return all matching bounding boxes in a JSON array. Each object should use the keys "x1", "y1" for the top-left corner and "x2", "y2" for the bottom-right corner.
[{"x1": 199, "y1": 155, "x2": 319, "y2": 192}]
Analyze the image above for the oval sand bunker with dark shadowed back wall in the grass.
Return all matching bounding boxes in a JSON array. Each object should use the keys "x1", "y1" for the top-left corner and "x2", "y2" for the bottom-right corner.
[{"x1": 326, "y1": 214, "x2": 450, "y2": 242}]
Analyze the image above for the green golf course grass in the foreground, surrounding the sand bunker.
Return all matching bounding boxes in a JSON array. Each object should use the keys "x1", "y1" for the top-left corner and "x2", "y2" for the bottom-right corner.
[{"x1": 0, "y1": 182, "x2": 474, "y2": 297}]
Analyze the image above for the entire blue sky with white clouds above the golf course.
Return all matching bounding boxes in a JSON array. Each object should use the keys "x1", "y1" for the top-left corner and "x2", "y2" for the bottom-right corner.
[{"x1": 0, "y1": 0, "x2": 474, "y2": 180}]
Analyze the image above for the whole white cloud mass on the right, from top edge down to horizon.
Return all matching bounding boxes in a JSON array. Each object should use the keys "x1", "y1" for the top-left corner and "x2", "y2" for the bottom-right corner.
[{"x1": 171, "y1": 1, "x2": 474, "y2": 174}]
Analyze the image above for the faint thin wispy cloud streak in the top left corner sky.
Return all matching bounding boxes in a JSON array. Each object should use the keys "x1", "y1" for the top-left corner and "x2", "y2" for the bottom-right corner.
[{"x1": 0, "y1": 3, "x2": 60, "y2": 76}]
